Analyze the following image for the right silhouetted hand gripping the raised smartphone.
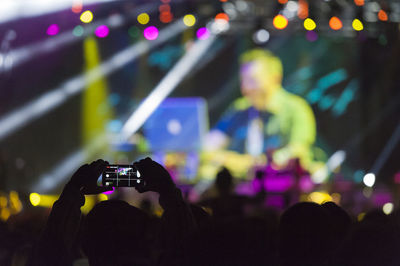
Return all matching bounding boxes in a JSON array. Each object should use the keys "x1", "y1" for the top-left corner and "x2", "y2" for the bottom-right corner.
[{"x1": 133, "y1": 157, "x2": 176, "y2": 193}]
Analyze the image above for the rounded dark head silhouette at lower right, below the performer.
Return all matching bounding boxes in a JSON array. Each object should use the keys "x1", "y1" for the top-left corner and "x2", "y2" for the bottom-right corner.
[{"x1": 279, "y1": 202, "x2": 333, "y2": 265}]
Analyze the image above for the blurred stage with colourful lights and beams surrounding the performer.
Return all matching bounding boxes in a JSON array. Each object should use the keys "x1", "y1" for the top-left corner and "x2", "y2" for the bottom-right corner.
[{"x1": 0, "y1": 0, "x2": 400, "y2": 220}]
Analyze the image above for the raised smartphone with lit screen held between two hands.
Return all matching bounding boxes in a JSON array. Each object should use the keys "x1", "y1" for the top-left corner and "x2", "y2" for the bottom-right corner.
[{"x1": 102, "y1": 164, "x2": 145, "y2": 187}]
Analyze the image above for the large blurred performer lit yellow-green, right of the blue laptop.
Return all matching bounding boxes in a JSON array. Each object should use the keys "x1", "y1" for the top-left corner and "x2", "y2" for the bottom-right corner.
[{"x1": 205, "y1": 49, "x2": 316, "y2": 175}]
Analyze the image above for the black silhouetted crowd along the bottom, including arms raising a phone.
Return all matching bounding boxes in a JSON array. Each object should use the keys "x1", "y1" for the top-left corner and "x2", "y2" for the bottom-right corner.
[{"x1": 0, "y1": 158, "x2": 400, "y2": 266}]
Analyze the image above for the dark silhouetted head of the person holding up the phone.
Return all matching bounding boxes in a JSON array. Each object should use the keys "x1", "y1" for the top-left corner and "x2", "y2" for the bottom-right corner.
[{"x1": 82, "y1": 200, "x2": 151, "y2": 266}]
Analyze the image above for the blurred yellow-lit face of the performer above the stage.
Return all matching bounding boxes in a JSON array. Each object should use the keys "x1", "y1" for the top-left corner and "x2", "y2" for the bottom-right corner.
[{"x1": 240, "y1": 61, "x2": 277, "y2": 110}]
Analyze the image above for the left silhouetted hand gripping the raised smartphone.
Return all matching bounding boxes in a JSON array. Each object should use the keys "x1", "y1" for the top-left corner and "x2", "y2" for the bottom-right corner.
[{"x1": 69, "y1": 159, "x2": 113, "y2": 195}]
